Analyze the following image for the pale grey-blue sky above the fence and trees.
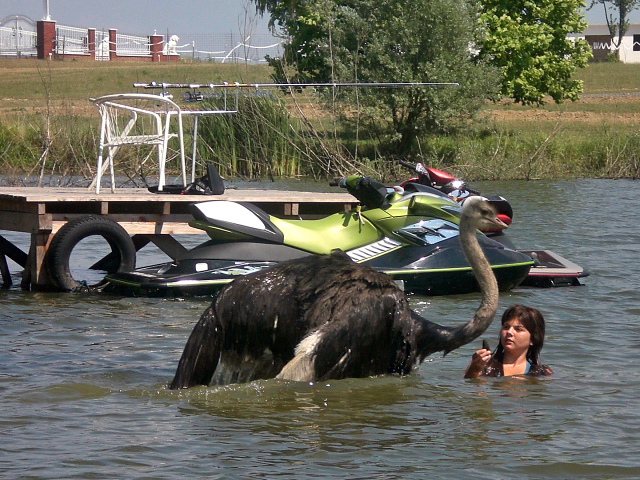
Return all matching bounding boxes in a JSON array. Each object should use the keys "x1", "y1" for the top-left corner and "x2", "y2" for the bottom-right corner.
[{"x1": 0, "y1": 0, "x2": 640, "y2": 35}]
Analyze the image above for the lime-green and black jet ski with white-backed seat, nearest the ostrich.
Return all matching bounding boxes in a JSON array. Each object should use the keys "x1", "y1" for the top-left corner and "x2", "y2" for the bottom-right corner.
[{"x1": 105, "y1": 175, "x2": 534, "y2": 296}]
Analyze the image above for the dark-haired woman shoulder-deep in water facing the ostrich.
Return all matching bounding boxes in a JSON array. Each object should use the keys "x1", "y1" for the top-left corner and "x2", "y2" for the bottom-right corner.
[{"x1": 464, "y1": 305, "x2": 553, "y2": 378}]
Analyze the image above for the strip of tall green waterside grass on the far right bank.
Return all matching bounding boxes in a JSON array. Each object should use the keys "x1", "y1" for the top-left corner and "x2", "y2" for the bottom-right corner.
[{"x1": 402, "y1": 126, "x2": 640, "y2": 181}]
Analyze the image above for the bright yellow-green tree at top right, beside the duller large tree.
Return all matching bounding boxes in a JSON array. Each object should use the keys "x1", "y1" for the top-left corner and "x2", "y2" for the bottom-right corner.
[{"x1": 481, "y1": 0, "x2": 591, "y2": 104}]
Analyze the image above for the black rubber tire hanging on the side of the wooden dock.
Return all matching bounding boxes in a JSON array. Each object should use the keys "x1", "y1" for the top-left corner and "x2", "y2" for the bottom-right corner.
[{"x1": 45, "y1": 215, "x2": 136, "y2": 291}]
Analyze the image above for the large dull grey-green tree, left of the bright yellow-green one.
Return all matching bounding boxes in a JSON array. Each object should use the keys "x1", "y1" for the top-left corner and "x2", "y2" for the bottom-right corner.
[{"x1": 256, "y1": 0, "x2": 499, "y2": 155}]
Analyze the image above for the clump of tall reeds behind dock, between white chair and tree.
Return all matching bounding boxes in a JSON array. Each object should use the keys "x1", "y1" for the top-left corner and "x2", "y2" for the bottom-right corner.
[{"x1": 192, "y1": 92, "x2": 363, "y2": 178}]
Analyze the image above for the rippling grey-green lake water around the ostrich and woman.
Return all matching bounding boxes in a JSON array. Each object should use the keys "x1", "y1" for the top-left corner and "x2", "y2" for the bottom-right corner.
[{"x1": 0, "y1": 180, "x2": 640, "y2": 479}]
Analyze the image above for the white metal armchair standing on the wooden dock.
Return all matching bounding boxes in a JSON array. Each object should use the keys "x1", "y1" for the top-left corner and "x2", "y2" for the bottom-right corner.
[{"x1": 89, "y1": 93, "x2": 187, "y2": 193}]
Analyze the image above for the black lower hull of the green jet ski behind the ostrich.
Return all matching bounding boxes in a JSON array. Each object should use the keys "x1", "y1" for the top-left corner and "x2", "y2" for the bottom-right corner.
[{"x1": 106, "y1": 237, "x2": 533, "y2": 297}]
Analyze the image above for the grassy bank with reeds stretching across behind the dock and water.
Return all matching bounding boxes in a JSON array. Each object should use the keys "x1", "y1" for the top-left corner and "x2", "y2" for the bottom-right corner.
[{"x1": 0, "y1": 59, "x2": 640, "y2": 182}]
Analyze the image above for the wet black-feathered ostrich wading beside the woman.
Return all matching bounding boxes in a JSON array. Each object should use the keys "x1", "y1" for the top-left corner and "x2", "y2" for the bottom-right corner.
[{"x1": 169, "y1": 197, "x2": 505, "y2": 389}]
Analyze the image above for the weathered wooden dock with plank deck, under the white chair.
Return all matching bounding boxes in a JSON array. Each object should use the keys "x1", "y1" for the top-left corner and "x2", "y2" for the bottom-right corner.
[{"x1": 0, "y1": 187, "x2": 357, "y2": 289}]
